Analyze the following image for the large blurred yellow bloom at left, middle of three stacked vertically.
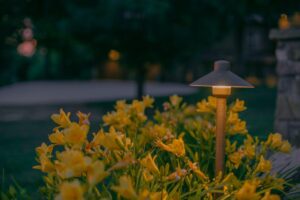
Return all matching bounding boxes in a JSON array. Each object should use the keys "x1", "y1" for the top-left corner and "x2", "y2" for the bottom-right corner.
[{"x1": 55, "y1": 150, "x2": 91, "y2": 178}]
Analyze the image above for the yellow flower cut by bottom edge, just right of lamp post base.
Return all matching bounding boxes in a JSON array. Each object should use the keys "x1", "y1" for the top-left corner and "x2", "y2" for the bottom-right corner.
[{"x1": 235, "y1": 181, "x2": 260, "y2": 200}]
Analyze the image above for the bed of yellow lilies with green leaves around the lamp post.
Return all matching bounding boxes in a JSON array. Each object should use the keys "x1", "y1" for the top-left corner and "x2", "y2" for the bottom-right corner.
[{"x1": 29, "y1": 96, "x2": 291, "y2": 200}]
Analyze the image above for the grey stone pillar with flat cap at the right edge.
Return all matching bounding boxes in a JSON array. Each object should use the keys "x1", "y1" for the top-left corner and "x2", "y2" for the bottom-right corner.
[{"x1": 270, "y1": 28, "x2": 300, "y2": 147}]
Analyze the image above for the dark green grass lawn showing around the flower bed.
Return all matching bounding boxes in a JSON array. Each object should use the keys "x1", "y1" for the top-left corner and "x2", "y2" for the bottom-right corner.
[{"x1": 0, "y1": 87, "x2": 276, "y2": 195}]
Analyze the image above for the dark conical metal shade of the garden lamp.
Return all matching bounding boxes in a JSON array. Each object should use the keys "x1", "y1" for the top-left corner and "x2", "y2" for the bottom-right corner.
[{"x1": 191, "y1": 60, "x2": 253, "y2": 88}]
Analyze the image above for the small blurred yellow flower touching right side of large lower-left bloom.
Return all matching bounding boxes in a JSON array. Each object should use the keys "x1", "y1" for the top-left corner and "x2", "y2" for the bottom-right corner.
[{"x1": 87, "y1": 160, "x2": 109, "y2": 185}]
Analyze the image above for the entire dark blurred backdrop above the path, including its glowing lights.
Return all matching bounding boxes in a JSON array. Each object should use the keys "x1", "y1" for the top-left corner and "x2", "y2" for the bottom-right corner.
[{"x1": 0, "y1": 0, "x2": 300, "y2": 89}]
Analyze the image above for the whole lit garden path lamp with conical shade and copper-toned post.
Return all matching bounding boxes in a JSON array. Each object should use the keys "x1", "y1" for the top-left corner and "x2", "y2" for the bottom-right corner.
[{"x1": 191, "y1": 60, "x2": 253, "y2": 176}]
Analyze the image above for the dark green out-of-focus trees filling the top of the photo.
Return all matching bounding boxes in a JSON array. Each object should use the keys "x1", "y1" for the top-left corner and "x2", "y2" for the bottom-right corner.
[{"x1": 0, "y1": 0, "x2": 300, "y2": 97}]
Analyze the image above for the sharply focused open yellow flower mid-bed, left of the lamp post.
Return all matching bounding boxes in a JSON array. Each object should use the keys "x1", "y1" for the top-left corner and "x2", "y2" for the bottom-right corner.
[{"x1": 156, "y1": 137, "x2": 185, "y2": 157}]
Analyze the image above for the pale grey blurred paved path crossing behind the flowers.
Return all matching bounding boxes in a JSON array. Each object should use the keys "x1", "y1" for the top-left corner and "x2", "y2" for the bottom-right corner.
[{"x1": 0, "y1": 80, "x2": 196, "y2": 106}]
